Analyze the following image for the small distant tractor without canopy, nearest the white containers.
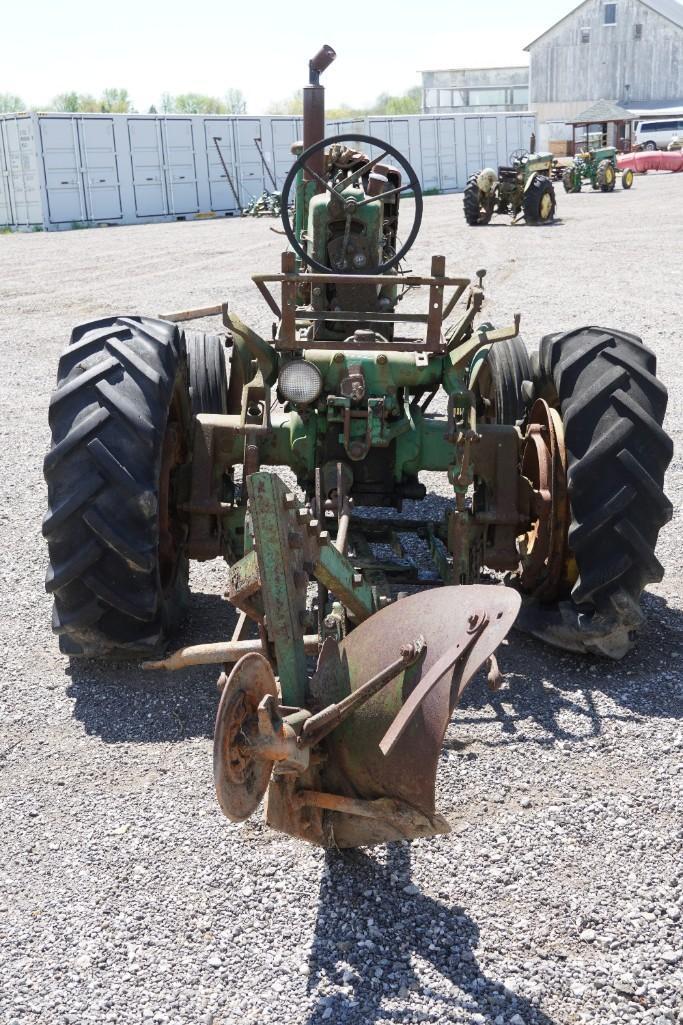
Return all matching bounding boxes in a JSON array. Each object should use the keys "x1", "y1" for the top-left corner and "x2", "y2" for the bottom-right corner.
[{"x1": 463, "y1": 150, "x2": 556, "y2": 226}]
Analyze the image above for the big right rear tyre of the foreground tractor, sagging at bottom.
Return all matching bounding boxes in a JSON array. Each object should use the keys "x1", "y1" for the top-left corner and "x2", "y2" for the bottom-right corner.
[{"x1": 521, "y1": 327, "x2": 673, "y2": 658}]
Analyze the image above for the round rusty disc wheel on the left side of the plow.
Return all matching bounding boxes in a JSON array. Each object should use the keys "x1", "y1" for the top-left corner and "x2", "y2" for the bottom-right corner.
[{"x1": 213, "y1": 653, "x2": 278, "y2": 822}]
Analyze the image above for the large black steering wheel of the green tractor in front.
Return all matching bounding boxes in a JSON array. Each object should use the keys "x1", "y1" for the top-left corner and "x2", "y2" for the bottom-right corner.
[{"x1": 281, "y1": 135, "x2": 423, "y2": 274}]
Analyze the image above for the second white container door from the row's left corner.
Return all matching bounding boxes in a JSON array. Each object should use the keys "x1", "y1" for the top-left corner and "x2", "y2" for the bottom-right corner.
[{"x1": 78, "y1": 118, "x2": 121, "y2": 220}]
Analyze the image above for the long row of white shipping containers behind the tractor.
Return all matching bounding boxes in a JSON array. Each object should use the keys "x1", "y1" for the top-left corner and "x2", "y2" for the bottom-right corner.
[{"x1": 0, "y1": 112, "x2": 535, "y2": 231}]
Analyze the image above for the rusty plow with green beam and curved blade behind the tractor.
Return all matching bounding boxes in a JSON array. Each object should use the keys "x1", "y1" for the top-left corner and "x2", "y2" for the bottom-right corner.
[{"x1": 150, "y1": 473, "x2": 520, "y2": 848}]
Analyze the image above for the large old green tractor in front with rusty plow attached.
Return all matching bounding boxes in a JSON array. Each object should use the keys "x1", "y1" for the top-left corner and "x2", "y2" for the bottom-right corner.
[{"x1": 43, "y1": 47, "x2": 672, "y2": 847}]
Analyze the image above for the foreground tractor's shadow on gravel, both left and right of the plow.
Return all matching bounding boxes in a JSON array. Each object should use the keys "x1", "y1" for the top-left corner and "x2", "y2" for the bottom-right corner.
[{"x1": 67, "y1": 574, "x2": 683, "y2": 747}]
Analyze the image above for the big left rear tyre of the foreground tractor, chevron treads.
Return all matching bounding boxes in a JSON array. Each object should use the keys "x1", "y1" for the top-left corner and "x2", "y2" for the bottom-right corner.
[{"x1": 43, "y1": 317, "x2": 192, "y2": 658}]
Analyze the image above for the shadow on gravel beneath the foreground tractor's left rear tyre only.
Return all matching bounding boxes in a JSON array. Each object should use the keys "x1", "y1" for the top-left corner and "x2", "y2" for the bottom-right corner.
[{"x1": 67, "y1": 592, "x2": 236, "y2": 744}]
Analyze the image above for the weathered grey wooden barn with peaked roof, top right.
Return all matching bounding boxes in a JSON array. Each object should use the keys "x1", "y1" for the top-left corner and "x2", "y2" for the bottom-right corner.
[{"x1": 525, "y1": 0, "x2": 683, "y2": 130}]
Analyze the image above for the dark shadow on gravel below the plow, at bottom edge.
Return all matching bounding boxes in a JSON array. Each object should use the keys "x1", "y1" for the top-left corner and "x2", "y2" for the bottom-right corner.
[{"x1": 306, "y1": 844, "x2": 556, "y2": 1025}]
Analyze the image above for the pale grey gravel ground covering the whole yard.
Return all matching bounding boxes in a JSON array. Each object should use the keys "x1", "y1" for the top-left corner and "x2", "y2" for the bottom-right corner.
[{"x1": 0, "y1": 175, "x2": 683, "y2": 1025}]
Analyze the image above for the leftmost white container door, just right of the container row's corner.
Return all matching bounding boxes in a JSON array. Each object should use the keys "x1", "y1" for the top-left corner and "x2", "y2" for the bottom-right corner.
[{"x1": 39, "y1": 117, "x2": 88, "y2": 224}]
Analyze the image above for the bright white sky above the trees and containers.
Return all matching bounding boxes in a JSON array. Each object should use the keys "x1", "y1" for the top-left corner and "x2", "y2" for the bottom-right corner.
[{"x1": 0, "y1": 0, "x2": 575, "y2": 114}]
